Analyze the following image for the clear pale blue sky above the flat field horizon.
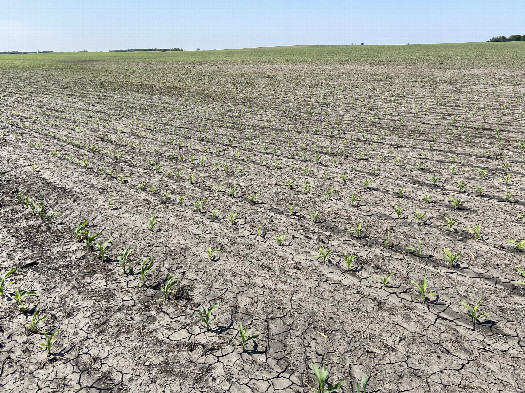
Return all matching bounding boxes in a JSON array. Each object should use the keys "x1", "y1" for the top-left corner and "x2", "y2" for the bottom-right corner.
[{"x1": 0, "y1": 0, "x2": 525, "y2": 51}]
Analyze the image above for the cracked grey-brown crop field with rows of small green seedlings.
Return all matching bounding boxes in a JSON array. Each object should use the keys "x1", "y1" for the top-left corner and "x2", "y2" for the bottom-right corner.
[{"x1": 0, "y1": 43, "x2": 525, "y2": 393}]
